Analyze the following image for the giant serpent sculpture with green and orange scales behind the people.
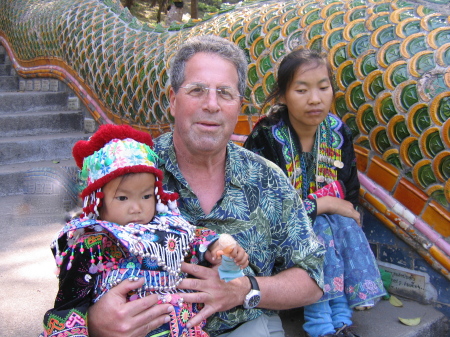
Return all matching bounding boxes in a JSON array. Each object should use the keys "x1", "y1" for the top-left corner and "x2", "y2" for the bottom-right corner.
[{"x1": 0, "y1": 0, "x2": 450, "y2": 279}]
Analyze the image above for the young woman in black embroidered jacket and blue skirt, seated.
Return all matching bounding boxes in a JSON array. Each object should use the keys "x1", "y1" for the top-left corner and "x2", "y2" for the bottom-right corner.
[{"x1": 244, "y1": 49, "x2": 385, "y2": 337}]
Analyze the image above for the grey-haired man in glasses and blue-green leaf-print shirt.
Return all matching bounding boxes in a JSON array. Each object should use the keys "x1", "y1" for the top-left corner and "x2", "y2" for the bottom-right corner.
[{"x1": 89, "y1": 36, "x2": 324, "y2": 337}]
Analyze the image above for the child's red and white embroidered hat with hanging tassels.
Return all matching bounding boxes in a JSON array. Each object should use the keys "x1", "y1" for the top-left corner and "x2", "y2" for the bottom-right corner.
[{"x1": 72, "y1": 124, "x2": 178, "y2": 218}]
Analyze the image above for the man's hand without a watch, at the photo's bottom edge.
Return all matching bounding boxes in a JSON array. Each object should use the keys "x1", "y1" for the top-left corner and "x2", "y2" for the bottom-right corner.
[{"x1": 88, "y1": 278, "x2": 173, "y2": 337}]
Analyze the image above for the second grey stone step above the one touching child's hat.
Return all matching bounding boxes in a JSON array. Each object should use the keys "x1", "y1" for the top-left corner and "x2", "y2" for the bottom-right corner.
[{"x1": 0, "y1": 91, "x2": 68, "y2": 114}]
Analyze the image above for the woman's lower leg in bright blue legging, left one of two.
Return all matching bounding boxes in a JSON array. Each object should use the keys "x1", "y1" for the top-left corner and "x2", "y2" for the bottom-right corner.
[{"x1": 303, "y1": 301, "x2": 335, "y2": 337}]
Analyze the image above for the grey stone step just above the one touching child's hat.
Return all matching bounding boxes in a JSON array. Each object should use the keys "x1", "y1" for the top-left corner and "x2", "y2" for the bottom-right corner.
[{"x1": 0, "y1": 111, "x2": 83, "y2": 138}]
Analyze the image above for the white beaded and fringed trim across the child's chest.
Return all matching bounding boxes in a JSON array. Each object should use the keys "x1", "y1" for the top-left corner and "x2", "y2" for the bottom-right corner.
[{"x1": 52, "y1": 213, "x2": 195, "y2": 301}]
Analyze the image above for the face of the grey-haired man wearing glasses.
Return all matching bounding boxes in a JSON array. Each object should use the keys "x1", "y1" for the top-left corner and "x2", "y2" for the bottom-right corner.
[{"x1": 170, "y1": 53, "x2": 241, "y2": 155}]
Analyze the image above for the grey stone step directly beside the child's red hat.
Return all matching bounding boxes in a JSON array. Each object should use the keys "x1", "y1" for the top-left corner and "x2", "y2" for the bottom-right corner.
[{"x1": 0, "y1": 132, "x2": 89, "y2": 165}]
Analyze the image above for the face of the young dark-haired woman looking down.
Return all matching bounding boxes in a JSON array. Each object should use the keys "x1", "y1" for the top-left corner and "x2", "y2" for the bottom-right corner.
[{"x1": 280, "y1": 64, "x2": 333, "y2": 131}]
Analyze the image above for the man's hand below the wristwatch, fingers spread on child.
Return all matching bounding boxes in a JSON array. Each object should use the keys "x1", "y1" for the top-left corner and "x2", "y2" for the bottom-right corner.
[{"x1": 178, "y1": 262, "x2": 250, "y2": 327}]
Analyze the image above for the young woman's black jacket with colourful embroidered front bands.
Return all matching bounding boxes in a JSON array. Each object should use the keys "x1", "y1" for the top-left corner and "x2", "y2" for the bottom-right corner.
[{"x1": 244, "y1": 111, "x2": 360, "y2": 220}]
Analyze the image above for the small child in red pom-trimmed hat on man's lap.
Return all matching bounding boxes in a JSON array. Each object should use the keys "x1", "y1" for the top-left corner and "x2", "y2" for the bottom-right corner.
[{"x1": 44, "y1": 125, "x2": 248, "y2": 337}]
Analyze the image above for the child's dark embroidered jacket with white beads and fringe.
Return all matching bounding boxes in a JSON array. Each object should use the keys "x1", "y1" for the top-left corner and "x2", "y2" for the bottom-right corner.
[{"x1": 43, "y1": 213, "x2": 218, "y2": 337}]
